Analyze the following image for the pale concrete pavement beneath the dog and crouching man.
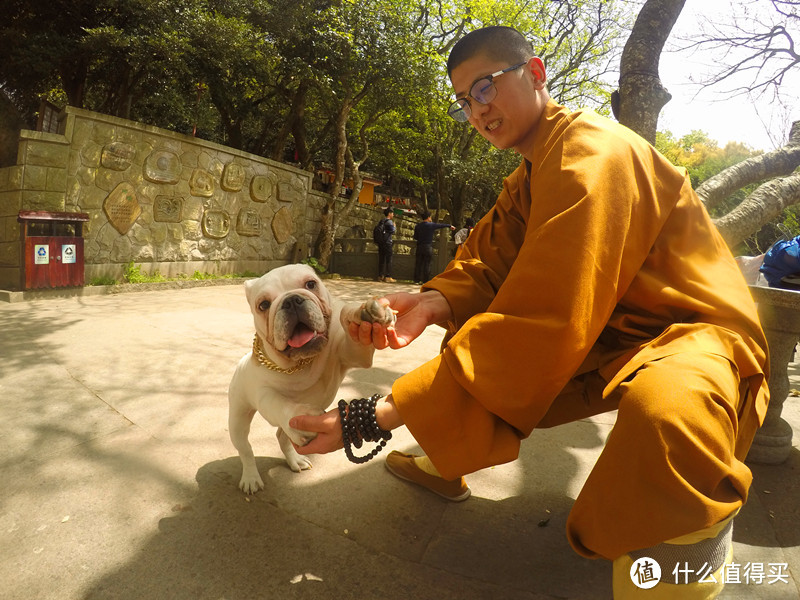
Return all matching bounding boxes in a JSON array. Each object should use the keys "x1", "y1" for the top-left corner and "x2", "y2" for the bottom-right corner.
[{"x1": 0, "y1": 280, "x2": 800, "y2": 600}]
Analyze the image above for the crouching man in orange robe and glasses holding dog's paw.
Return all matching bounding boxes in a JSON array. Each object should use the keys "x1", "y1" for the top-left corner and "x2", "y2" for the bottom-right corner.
[{"x1": 292, "y1": 27, "x2": 768, "y2": 599}]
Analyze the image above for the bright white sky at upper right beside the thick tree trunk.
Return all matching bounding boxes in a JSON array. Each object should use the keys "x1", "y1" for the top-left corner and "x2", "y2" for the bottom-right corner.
[{"x1": 658, "y1": 0, "x2": 800, "y2": 151}]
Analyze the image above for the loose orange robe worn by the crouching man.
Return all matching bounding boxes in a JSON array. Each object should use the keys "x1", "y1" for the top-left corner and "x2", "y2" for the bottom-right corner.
[{"x1": 392, "y1": 101, "x2": 768, "y2": 558}]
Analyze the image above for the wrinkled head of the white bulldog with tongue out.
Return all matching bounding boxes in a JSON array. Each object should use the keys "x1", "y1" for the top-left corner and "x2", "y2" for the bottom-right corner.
[{"x1": 245, "y1": 265, "x2": 331, "y2": 360}]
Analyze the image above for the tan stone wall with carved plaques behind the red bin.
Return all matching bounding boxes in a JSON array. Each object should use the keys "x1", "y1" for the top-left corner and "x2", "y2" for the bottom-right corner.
[{"x1": 0, "y1": 107, "x2": 328, "y2": 289}]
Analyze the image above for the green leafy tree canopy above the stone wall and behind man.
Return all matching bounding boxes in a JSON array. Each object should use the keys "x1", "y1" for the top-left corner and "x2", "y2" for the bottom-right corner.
[{"x1": 0, "y1": 0, "x2": 797, "y2": 264}]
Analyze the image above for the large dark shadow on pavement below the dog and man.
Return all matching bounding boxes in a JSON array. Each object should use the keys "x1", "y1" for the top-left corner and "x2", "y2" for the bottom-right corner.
[{"x1": 85, "y1": 423, "x2": 610, "y2": 600}]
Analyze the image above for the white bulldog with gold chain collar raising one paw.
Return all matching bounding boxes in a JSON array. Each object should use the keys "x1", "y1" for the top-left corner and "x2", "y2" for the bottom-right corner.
[{"x1": 228, "y1": 265, "x2": 394, "y2": 494}]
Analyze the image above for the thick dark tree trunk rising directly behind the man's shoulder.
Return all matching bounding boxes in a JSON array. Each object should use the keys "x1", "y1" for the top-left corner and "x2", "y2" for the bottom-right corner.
[{"x1": 611, "y1": 0, "x2": 686, "y2": 144}]
